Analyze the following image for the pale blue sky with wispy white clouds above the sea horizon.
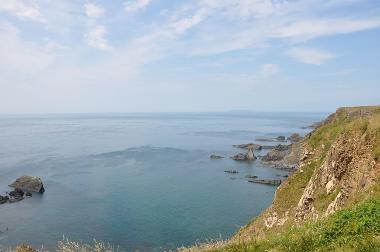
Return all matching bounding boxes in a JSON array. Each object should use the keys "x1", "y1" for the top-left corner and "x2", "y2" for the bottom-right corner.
[{"x1": 0, "y1": 0, "x2": 380, "y2": 114}]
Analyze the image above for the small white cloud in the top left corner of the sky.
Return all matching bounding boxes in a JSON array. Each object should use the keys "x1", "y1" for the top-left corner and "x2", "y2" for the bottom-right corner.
[{"x1": 0, "y1": 0, "x2": 45, "y2": 22}]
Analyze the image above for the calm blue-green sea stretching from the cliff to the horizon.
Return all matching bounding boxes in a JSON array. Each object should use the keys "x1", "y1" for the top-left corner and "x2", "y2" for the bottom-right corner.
[{"x1": 0, "y1": 113, "x2": 326, "y2": 251}]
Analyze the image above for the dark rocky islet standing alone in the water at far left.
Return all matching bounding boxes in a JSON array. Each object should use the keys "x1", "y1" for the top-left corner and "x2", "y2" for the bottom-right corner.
[{"x1": 0, "y1": 176, "x2": 45, "y2": 204}]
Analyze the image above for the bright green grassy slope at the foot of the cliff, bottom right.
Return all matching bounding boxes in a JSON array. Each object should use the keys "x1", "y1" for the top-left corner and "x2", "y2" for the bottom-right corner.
[{"x1": 209, "y1": 199, "x2": 380, "y2": 252}]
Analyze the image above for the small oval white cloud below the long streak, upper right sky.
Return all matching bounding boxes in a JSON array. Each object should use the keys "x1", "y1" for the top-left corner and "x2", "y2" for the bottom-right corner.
[{"x1": 287, "y1": 47, "x2": 336, "y2": 65}]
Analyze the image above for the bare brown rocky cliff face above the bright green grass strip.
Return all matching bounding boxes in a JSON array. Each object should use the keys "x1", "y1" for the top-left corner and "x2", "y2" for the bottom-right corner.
[{"x1": 233, "y1": 107, "x2": 380, "y2": 241}]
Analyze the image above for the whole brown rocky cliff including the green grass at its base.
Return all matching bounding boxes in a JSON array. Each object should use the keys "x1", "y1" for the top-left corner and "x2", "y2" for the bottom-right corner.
[{"x1": 187, "y1": 106, "x2": 380, "y2": 251}]
